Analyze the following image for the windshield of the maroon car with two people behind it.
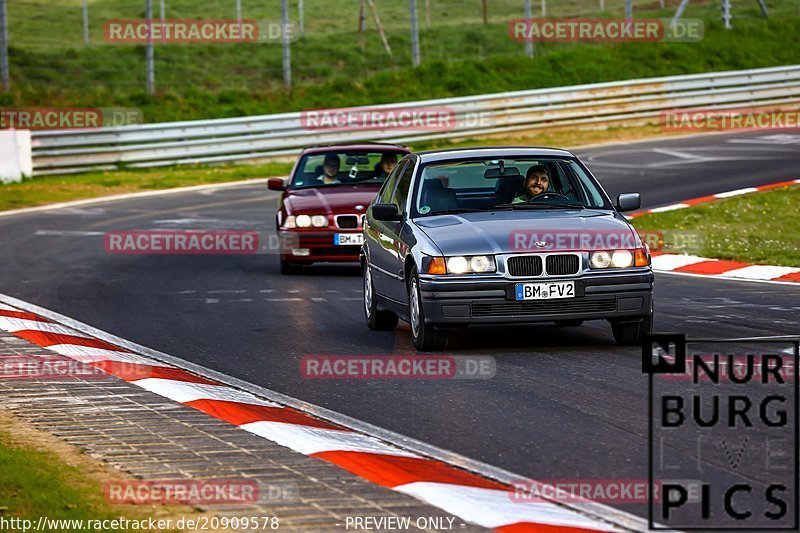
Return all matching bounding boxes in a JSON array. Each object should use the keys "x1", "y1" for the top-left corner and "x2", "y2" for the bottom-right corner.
[{"x1": 290, "y1": 150, "x2": 405, "y2": 189}]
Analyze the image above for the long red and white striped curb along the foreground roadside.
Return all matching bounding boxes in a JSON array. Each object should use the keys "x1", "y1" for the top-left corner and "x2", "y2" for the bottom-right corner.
[{"x1": 0, "y1": 295, "x2": 647, "y2": 533}]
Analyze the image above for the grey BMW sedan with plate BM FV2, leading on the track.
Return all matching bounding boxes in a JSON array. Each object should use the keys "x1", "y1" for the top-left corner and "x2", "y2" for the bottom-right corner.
[{"x1": 361, "y1": 148, "x2": 653, "y2": 351}]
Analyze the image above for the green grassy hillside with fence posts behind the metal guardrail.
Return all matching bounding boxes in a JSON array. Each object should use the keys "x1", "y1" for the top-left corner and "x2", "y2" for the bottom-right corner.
[{"x1": 0, "y1": 0, "x2": 800, "y2": 122}]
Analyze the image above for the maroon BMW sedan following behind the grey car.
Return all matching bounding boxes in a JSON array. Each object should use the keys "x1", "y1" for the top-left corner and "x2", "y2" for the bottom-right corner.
[{"x1": 268, "y1": 143, "x2": 409, "y2": 274}]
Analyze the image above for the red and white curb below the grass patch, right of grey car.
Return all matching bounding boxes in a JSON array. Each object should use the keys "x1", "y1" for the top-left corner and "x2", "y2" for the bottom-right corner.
[{"x1": 652, "y1": 253, "x2": 800, "y2": 283}]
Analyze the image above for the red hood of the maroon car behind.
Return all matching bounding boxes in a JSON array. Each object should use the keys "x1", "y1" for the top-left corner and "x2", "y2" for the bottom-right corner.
[{"x1": 284, "y1": 185, "x2": 380, "y2": 215}]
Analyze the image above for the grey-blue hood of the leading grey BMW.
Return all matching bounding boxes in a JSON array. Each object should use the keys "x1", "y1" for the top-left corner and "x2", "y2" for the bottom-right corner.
[{"x1": 414, "y1": 209, "x2": 640, "y2": 256}]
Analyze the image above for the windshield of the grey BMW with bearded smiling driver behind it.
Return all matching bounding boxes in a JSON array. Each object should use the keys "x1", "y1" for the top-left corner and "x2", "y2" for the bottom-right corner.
[{"x1": 413, "y1": 157, "x2": 611, "y2": 216}]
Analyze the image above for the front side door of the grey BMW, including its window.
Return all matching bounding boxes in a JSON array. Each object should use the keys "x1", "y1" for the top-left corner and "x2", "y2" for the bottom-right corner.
[{"x1": 382, "y1": 159, "x2": 416, "y2": 302}]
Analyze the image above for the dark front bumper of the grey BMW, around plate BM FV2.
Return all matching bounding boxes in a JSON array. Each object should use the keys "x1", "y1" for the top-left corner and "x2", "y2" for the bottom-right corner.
[{"x1": 420, "y1": 271, "x2": 654, "y2": 325}]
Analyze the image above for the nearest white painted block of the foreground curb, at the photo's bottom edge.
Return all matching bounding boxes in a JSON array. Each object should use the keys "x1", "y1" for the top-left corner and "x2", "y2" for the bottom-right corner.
[{"x1": 394, "y1": 481, "x2": 622, "y2": 531}]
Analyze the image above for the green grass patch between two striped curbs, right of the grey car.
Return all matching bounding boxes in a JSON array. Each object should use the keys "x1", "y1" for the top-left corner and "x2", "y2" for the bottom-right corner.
[{"x1": 633, "y1": 186, "x2": 800, "y2": 267}]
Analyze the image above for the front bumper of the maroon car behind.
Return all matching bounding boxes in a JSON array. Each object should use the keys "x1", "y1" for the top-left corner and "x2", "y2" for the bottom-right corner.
[{"x1": 278, "y1": 230, "x2": 361, "y2": 264}]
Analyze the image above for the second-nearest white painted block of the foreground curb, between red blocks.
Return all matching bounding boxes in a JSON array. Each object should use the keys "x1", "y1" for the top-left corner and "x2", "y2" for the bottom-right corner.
[{"x1": 239, "y1": 421, "x2": 419, "y2": 457}]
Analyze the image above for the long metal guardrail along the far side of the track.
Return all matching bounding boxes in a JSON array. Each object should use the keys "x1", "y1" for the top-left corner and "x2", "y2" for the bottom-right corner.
[{"x1": 32, "y1": 65, "x2": 800, "y2": 175}]
